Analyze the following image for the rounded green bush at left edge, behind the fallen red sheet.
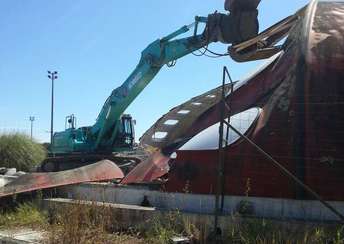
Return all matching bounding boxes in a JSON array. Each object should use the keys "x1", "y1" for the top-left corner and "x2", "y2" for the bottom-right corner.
[{"x1": 0, "y1": 133, "x2": 46, "y2": 171}]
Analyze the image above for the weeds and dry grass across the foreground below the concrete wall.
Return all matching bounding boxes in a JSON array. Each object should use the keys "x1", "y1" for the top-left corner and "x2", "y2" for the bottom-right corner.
[{"x1": 0, "y1": 199, "x2": 344, "y2": 244}]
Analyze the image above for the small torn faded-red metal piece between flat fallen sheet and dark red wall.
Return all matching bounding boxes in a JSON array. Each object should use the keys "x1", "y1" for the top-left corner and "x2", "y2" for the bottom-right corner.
[{"x1": 121, "y1": 151, "x2": 170, "y2": 184}]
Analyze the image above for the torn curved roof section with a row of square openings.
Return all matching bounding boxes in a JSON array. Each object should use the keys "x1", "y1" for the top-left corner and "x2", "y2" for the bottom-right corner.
[{"x1": 140, "y1": 52, "x2": 282, "y2": 153}]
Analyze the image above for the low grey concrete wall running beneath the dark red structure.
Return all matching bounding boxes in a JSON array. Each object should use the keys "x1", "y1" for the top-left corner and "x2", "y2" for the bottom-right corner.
[{"x1": 60, "y1": 183, "x2": 344, "y2": 221}]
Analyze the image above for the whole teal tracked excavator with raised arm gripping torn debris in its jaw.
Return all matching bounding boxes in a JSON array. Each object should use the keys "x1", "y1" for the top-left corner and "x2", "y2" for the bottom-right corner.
[{"x1": 40, "y1": 0, "x2": 295, "y2": 172}]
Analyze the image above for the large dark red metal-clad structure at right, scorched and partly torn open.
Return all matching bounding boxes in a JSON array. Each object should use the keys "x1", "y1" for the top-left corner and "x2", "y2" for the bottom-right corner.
[{"x1": 165, "y1": 1, "x2": 344, "y2": 201}]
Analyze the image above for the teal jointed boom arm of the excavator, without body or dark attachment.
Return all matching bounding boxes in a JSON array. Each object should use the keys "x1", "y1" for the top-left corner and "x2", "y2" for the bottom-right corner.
[{"x1": 90, "y1": 17, "x2": 208, "y2": 150}]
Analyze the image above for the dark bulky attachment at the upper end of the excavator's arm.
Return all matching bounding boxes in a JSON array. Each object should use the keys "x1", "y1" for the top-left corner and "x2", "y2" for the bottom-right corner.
[{"x1": 205, "y1": 0, "x2": 261, "y2": 45}]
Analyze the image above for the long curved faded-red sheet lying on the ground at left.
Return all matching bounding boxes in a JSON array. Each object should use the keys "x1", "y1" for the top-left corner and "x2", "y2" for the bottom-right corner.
[{"x1": 0, "y1": 160, "x2": 124, "y2": 198}]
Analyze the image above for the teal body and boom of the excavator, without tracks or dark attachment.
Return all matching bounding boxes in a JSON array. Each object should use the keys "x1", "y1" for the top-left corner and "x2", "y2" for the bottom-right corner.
[{"x1": 51, "y1": 17, "x2": 208, "y2": 153}]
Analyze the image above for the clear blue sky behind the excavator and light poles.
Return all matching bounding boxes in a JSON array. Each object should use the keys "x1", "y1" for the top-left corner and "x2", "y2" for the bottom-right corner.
[{"x1": 0, "y1": 0, "x2": 308, "y2": 141}]
